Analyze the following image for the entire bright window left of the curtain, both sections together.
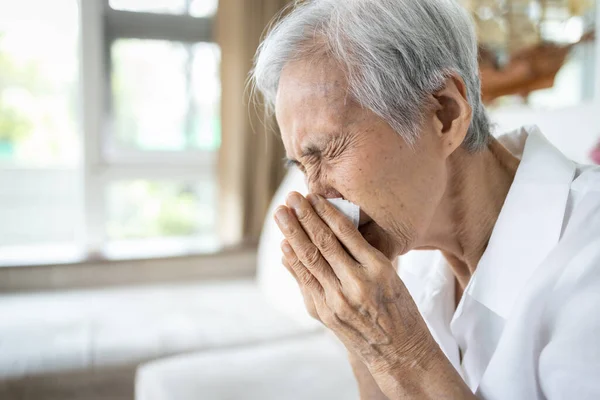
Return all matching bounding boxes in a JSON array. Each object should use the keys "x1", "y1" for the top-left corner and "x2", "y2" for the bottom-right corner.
[{"x1": 0, "y1": 0, "x2": 221, "y2": 265}]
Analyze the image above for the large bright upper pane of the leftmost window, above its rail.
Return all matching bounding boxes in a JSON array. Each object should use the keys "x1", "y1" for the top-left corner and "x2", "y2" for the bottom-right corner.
[{"x1": 0, "y1": 0, "x2": 78, "y2": 167}]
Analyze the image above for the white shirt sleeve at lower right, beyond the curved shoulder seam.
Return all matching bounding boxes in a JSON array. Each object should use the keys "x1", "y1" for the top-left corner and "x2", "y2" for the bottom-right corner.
[{"x1": 538, "y1": 236, "x2": 600, "y2": 399}]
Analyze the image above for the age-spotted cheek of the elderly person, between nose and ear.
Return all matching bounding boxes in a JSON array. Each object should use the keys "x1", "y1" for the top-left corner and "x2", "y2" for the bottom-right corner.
[{"x1": 323, "y1": 133, "x2": 445, "y2": 230}]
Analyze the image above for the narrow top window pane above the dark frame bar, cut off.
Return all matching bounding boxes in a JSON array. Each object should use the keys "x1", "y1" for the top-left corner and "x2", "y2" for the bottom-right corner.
[{"x1": 110, "y1": 0, "x2": 218, "y2": 17}]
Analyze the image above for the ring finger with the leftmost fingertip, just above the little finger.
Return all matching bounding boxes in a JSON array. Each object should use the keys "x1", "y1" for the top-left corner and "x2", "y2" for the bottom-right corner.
[{"x1": 275, "y1": 206, "x2": 339, "y2": 290}]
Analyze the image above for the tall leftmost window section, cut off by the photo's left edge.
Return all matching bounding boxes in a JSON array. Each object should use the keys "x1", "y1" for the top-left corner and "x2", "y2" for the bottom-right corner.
[{"x1": 0, "y1": 0, "x2": 81, "y2": 258}]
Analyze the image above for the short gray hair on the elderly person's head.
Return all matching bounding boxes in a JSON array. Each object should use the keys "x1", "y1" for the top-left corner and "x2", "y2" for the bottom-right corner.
[{"x1": 251, "y1": 0, "x2": 490, "y2": 151}]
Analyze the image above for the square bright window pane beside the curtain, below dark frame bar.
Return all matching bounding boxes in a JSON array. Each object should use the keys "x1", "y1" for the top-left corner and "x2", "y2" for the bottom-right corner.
[{"x1": 112, "y1": 39, "x2": 221, "y2": 151}]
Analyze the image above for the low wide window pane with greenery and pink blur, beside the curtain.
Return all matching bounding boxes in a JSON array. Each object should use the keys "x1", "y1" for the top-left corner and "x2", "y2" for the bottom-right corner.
[{"x1": 107, "y1": 180, "x2": 217, "y2": 240}]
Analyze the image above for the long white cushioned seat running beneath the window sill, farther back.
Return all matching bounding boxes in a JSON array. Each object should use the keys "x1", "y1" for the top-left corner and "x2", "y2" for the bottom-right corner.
[{"x1": 0, "y1": 280, "x2": 316, "y2": 378}]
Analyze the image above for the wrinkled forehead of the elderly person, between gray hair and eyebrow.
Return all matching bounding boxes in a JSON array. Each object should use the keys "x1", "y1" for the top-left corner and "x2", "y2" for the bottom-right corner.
[{"x1": 275, "y1": 61, "x2": 355, "y2": 155}]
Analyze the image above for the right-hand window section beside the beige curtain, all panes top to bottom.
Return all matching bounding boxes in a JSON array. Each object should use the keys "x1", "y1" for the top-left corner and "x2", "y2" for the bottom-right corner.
[{"x1": 100, "y1": 0, "x2": 221, "y2": 256}]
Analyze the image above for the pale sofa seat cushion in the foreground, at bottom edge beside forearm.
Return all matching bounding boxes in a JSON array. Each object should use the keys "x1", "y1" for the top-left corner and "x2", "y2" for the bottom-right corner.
[{"x1": 136, "y1": 333, "x2": 359, "y2": 400}]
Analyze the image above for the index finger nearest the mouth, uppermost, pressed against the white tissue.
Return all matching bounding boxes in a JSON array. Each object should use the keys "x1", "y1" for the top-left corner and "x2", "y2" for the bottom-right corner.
[{"x1": 308, "y1": 194, "x2": 382, "y2": 266}]
